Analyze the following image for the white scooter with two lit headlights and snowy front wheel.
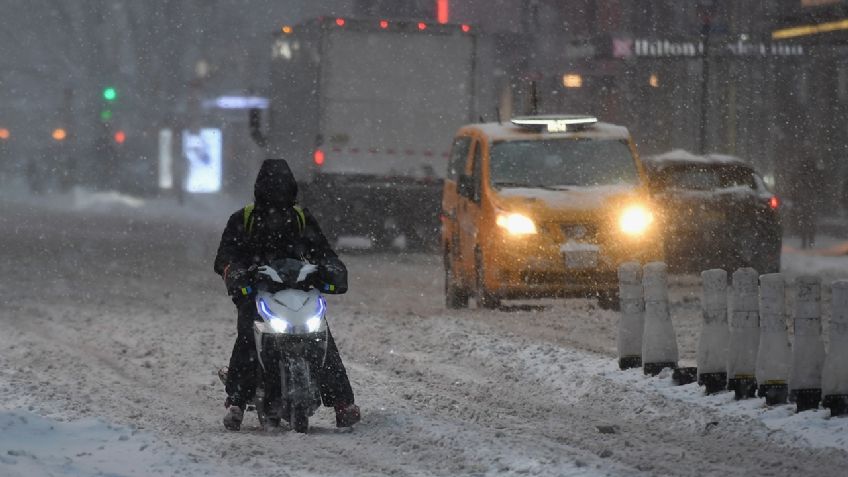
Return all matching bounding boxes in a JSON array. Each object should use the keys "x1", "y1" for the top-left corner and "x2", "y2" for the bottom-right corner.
[{"x1": 219, "y1": 259, "x2": 328, "y2": 433}]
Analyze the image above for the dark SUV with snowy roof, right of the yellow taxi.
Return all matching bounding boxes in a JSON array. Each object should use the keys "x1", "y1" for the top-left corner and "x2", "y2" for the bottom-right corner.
[{"x1": 643, "y1": 150, "x2": 783, "y2": 273}]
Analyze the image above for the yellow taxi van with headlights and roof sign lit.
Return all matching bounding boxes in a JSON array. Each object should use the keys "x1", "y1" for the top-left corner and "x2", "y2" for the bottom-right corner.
[{"x1": 442, "y1": 115, "x2": 662, "y2": 309}]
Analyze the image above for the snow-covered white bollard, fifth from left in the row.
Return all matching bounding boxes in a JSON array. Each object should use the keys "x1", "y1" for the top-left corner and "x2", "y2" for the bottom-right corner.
[{"x1": 756, "y1": 273, "x2": 792, "y2": 406}]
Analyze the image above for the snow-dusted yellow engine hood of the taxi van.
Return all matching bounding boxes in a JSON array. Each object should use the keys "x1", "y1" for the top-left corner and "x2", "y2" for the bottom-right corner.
[{"x1": 496, "y1": 185, "x2": 644, "y2": 221}]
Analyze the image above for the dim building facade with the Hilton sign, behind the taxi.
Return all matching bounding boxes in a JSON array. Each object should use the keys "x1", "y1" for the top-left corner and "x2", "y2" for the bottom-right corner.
[{"x1": 440, "y1": 0, "x2": 848, "y2": 214}]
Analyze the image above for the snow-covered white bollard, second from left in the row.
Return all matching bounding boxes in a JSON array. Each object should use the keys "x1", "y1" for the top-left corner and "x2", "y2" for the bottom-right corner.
[{"x1": 642, "y1": 262, "x2": 678, "y2": 376}]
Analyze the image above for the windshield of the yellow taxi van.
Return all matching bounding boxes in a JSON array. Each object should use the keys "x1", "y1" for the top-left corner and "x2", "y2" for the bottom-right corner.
[{"x1": 490, "y1": 139, "x2": 639, "y2": 188}]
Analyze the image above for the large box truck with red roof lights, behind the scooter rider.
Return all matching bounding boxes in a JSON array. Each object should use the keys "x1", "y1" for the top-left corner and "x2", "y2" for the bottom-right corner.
[{"x1": 251, "y1": 18, "x2": 476, "y2": 245}]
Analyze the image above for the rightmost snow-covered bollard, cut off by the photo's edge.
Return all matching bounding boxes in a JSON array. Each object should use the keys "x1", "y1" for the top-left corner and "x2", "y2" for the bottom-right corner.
[{"x1": 822, "y1": 280, "x2": 848, "y2": 416}]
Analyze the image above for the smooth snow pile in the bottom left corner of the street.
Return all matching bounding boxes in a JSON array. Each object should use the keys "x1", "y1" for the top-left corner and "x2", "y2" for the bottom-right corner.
[{"x1": 0, "y1": 410, "x2": 225, "y2": 477}]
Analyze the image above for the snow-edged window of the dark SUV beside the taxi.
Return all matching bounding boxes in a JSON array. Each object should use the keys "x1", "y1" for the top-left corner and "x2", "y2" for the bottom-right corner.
[{"x1": 651, "y1": 164, "x2": 756, "y2": 190}]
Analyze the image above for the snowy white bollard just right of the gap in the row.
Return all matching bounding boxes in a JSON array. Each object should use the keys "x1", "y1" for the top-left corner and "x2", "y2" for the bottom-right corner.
[{"x1": 698, "y1": 269, "x2": 730, "y2": 394}]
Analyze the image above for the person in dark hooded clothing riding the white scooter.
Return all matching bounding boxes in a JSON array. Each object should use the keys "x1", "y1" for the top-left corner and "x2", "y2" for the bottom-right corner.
[{"x1": 215, "y1": 159, "x2": 360, "y2": 430}]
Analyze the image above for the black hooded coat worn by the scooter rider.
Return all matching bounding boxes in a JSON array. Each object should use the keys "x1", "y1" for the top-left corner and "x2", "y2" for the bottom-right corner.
[{"x1": 215, "y1": 159, "x2": 343, "y2": 286}]
